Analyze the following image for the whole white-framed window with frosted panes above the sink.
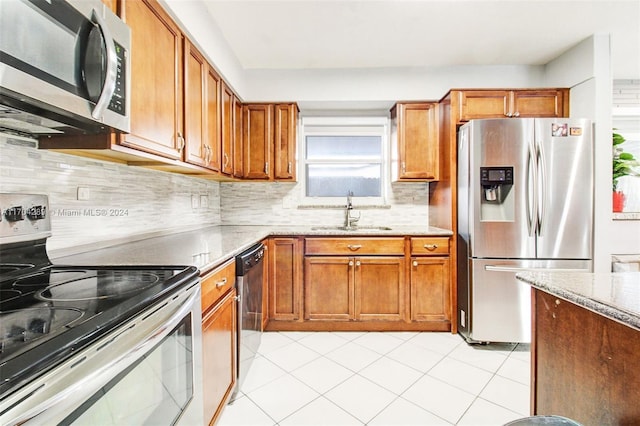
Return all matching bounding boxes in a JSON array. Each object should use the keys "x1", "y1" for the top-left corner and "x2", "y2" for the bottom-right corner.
[{"x1": 302, "y1": 117, "x2": 387, "y2": 204}]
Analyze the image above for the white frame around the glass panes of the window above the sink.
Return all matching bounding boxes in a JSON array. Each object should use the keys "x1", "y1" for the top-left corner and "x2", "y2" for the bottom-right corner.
[{"x1": 298, "y1": 115, "x2": 391, "y2": 206}]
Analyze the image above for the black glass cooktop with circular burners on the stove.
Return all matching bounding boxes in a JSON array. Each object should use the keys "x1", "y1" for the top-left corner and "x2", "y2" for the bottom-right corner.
[{"x1": 0, "y1": 263, "x2": 198, "y2": 396}]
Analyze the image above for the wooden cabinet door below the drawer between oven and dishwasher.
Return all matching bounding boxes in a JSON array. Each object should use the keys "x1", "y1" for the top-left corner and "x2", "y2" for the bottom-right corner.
[{"x1": 202, "y1": 289, "x2": 237, "y2": 425}]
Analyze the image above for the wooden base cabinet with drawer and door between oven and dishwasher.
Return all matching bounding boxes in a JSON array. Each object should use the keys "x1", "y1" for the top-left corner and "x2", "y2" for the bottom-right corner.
[{"x1": 201, "y1": 259, "x2": 237, "y2": 425}]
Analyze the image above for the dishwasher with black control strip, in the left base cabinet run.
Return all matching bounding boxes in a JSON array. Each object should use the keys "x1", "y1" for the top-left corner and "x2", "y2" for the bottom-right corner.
[{"x1": 231, "y1": 243, "x2": 264, "y2": 401}]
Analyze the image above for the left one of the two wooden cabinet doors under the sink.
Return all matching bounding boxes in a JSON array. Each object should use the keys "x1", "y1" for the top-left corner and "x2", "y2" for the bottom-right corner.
[{"x1": 304, "y1": 256, "x2": 355, "y2": 321}]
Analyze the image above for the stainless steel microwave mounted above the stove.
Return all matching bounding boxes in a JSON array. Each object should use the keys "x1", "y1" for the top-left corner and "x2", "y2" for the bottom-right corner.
[{"x1": 0, "y1": 0, "x2": 131, "y2": 136}]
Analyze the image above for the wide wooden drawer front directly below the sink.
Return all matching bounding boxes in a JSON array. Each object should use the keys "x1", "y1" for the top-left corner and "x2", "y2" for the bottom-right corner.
[{"x1": 305, "y1": 237, "x2": 404, "y2": 255}]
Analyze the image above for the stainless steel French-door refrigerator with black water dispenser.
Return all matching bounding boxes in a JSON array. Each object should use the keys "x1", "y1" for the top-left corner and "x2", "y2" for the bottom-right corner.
[{"x1": 458, "y1": 118, "x2": 594, "y2": 342}]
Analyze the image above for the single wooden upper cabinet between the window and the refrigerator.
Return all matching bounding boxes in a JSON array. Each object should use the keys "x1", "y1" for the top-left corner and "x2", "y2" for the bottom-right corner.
[{"x1": 391, "y1": 102, "x2": 440, "y2": 181}]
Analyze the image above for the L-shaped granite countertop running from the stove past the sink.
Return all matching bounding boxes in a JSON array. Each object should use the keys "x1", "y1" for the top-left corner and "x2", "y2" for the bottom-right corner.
[{"x1": 49, "y1": 226, "x2": 452, "y2": 273}]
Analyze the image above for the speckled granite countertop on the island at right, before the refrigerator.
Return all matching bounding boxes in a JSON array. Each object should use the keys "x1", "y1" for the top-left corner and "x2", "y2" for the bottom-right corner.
[{"x1": 516, "y1": 272, "x2": 640, "y2": 330}]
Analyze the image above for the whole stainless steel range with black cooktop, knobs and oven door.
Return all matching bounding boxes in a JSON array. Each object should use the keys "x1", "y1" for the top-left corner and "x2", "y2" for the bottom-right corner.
[{"x1": 0, "y1": 194, "x2": 203, "y2": 426}]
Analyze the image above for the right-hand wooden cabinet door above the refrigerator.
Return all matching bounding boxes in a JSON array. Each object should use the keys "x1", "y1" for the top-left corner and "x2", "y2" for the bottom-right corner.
[{"x1": 512, "y1": 90, "x2": 565, "y2": 117}]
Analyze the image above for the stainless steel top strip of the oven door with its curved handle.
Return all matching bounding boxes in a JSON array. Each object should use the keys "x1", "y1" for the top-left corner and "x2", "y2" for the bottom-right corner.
[{"x1": 0, "y1": 285, "x2": 200, "y2": 425}]
